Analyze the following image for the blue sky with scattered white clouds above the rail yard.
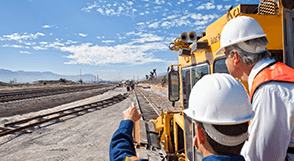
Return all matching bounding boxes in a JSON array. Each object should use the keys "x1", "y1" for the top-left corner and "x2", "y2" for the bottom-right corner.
[{"x1": 0, "y1": 0, "x2": 259, "y2": 80}]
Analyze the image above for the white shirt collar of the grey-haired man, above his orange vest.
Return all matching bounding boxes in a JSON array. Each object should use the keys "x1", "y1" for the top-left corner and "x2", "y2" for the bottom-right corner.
[{"x1": 248, "y1": 58, "x2": 275, "y2": 91}]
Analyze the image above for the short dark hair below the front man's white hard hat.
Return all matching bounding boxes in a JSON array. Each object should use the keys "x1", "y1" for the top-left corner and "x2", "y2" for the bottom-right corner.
[{"x1": 196, "y1": 121, "x2": 249, "y2": 155}]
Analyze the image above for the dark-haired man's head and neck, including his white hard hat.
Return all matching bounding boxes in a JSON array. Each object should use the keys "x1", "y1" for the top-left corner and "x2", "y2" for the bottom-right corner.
[{"x1": 184, "y1": 74, "x2": 254, "y2": 161}]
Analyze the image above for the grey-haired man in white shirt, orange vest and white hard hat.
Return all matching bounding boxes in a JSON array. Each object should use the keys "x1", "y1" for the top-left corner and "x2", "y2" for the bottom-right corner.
[{"x1": 217, "y1": 16, "x2": 294, "y2": 161}]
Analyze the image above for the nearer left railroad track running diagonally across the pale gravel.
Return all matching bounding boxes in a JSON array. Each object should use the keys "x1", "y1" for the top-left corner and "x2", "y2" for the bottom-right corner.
[{"x1": 0, "y1": 93, "x2": 129, "y2": 137}]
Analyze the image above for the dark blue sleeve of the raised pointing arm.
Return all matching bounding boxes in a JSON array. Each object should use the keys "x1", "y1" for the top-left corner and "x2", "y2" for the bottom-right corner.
[{"x1": 109, "y1": 120, "x2": 146, "y2": 161}]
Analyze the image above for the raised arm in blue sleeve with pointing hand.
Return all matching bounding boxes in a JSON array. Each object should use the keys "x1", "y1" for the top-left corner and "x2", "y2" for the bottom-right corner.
[{"x1": 109, "y1": 103, "x2": 146, "y2": 161}]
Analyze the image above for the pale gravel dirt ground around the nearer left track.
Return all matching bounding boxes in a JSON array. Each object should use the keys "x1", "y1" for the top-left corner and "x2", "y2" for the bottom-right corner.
[{"x1": 0, "y1": 85, "x2": 171, "y2": 161}]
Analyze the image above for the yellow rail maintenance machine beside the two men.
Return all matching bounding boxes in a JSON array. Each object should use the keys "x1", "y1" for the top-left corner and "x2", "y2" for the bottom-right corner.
[{"x1": 136, "y1": 0, "x2": 294, "y2": 161}]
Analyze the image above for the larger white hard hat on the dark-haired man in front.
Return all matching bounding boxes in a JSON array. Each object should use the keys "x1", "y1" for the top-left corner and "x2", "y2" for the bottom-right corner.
[{"x1": 184, "y1": 73, "x2": 254, "y2": 125}]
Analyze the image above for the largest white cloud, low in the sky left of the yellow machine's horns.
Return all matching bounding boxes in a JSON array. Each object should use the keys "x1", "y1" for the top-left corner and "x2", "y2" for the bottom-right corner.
[{"x1": 60, "y1": 32, "x2": 168, "y2": 65}]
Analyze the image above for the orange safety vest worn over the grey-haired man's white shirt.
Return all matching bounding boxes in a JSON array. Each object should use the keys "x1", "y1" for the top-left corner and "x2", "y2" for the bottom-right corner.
[{"x1": 249, "y1": 62, "x2": 294, "y2": 102}]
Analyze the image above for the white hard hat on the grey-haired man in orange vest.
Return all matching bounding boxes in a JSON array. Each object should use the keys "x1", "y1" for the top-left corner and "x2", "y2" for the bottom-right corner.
[{"x1": 216, "y1": 16, "x2": 266, "y2": 55}]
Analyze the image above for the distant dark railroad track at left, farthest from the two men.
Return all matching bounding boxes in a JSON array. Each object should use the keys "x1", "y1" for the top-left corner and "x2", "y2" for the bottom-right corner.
[{"x1": 0, "y1": 85, "x2": 110, "y2": 102}]
